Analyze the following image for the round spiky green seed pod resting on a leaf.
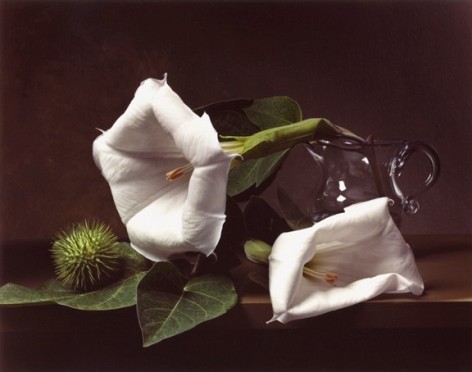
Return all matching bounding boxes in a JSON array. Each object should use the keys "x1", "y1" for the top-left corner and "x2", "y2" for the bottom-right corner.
[{"x1": 51, "y1": 221, "x2": 122, "y2": 291}]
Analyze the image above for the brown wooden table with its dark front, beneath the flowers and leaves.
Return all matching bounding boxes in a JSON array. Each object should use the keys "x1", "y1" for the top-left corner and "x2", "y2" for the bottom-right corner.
[{"x1": 0, "y1": 235, "x2": 472, "y2": 372}]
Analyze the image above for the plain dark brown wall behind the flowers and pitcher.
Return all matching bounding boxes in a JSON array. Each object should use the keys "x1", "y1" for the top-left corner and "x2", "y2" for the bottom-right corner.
[{"x1": 1, "y1": 1, "x2": 472, "y2": 240}]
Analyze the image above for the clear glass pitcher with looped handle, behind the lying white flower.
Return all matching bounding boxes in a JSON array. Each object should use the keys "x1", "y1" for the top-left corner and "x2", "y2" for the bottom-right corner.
[{"x1": 279, "y1": 136, "x2": 440, "y2": 224}]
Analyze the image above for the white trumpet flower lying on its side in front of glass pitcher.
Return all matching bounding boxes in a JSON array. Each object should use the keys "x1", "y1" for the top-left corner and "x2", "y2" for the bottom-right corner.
[{"x1": 269, "y1": 197, "x2": 424, "y2": 323}]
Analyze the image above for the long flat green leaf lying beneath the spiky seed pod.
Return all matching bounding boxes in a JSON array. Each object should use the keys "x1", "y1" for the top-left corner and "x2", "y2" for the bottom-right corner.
[{"x1": 0, "y1": 243, "x2": 149, "y2": 310}]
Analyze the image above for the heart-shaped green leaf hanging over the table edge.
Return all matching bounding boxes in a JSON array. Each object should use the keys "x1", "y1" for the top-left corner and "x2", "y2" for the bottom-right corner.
[{"x1": 137, "y1": 262, "x2": 237, "y2": 347}]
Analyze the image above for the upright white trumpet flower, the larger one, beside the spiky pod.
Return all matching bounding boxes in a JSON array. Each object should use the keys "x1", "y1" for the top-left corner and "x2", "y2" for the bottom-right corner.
[{"x1": 93, "y1": 76, "x2": 232, "y2": 261}]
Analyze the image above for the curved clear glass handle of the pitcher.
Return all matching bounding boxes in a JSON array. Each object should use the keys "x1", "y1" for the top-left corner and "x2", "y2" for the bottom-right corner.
[{"x1": 388, "y1": 141, "x2": 440, "y2": 215}]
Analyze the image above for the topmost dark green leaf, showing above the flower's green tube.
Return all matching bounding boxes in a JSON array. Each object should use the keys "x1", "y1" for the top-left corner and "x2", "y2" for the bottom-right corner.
[{"x1": 244, "y1": 96, "x2": 302, "y2": 130}]
